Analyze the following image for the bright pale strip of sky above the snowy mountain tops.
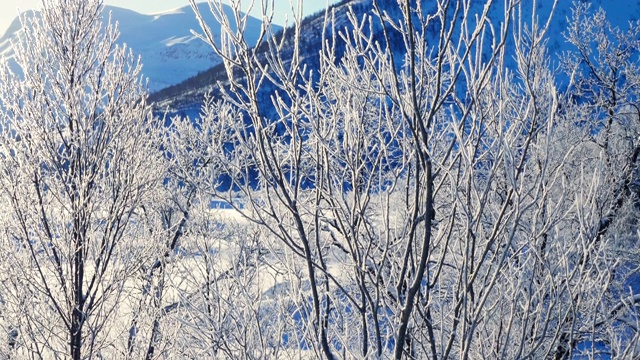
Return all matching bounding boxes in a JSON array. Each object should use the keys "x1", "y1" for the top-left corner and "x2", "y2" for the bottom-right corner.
[{"x1": 0, "y1": 0, "x2": 337, "y2": 37}]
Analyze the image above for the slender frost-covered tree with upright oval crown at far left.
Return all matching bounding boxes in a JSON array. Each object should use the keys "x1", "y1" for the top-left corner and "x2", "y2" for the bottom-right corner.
[{"x1": 0, "y1": 0, "x2": 164, "y2": 359}]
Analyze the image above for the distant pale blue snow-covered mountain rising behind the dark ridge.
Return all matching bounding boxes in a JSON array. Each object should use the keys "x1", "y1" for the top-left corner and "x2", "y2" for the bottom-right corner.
[{"x1": 0, "y1": 3, "x2": 280, "y2": 92}]
